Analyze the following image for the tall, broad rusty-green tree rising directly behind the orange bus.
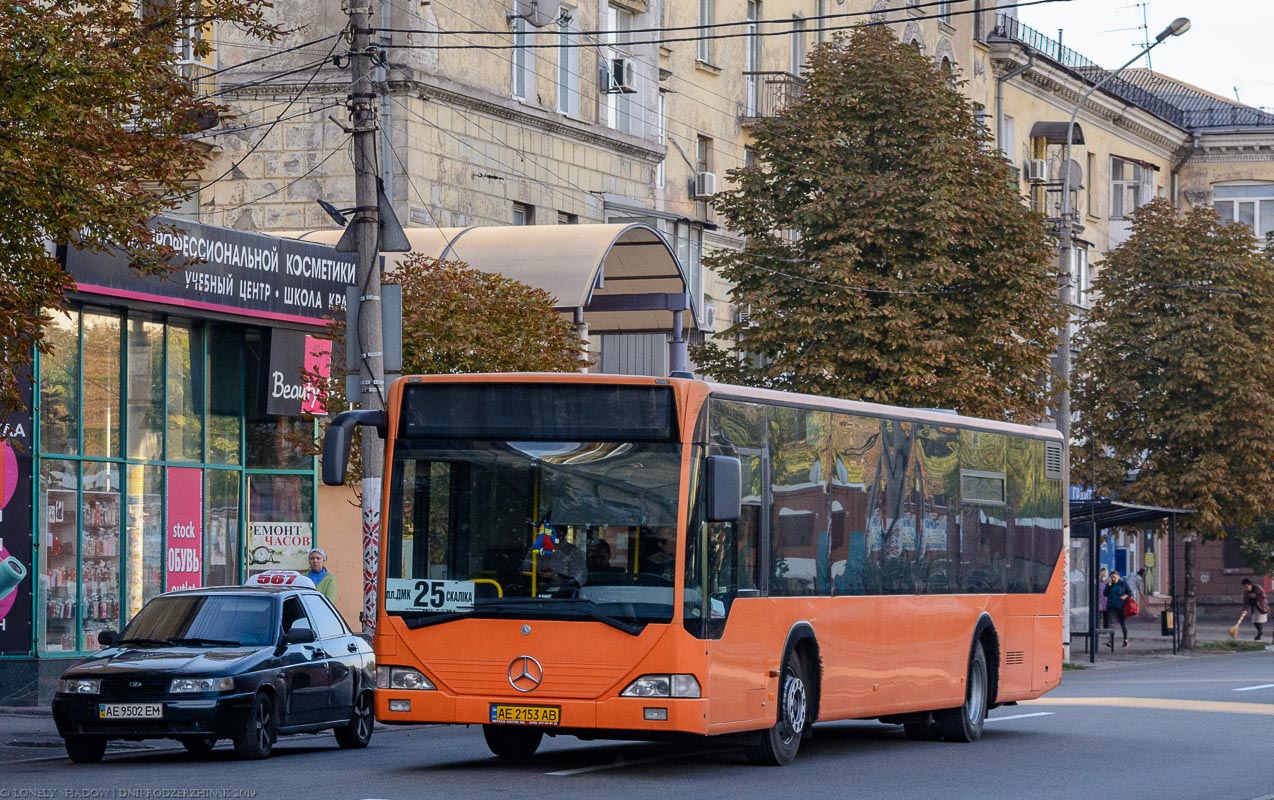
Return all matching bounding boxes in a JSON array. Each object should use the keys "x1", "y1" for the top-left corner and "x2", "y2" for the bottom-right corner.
[{"x1": 692, "y1": 25, "x2": 1061, "y2": 422}]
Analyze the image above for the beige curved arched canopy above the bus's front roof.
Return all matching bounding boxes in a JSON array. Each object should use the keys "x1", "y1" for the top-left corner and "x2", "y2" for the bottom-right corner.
[{"x1": 276, "y1": 223, "x2": 696, "y2": 334}]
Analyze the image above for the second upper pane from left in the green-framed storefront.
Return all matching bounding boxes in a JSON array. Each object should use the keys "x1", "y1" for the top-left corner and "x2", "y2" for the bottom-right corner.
[{"x1": 83, "y1": 311, "x2": 124, "y2": 459}]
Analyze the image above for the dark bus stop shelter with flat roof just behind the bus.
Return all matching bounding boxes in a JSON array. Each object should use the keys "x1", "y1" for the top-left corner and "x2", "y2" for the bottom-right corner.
[{"x1": 1070, "y1": 487, "x2": 1194, "y2": 662}]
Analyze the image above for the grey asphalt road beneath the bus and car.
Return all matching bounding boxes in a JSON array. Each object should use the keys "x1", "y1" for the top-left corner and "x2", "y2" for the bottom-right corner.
[{"x1": 0, "y1": 652, "x2": 1274, "y2": 800}]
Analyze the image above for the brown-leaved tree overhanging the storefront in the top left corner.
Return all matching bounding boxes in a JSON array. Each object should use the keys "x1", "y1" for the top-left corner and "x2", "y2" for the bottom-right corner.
[{"x1": 0, "y1": 0, "x2": 282, "y2": 409}]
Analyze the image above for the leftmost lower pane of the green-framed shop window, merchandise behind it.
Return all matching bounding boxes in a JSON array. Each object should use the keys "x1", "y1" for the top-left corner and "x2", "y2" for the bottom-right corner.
[{"x1": 38, "y1": 459, "x2": 79, "y2": 652}]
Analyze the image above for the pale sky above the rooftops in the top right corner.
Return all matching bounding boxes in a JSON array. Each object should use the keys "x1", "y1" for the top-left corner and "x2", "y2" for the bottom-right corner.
[{"x1": 1018, "y1": 0, "x2": 1274, "y2": 111}]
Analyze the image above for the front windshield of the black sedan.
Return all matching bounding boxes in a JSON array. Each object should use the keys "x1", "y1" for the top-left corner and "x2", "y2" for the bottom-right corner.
[{"x1": 120, "y1": 595, "x2": 279, "y2": 647}]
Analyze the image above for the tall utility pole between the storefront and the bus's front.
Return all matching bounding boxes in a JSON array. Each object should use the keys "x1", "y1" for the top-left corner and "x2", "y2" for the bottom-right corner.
[{"x1": 345, "y1": 0, "x2": 385, "y2": 632}]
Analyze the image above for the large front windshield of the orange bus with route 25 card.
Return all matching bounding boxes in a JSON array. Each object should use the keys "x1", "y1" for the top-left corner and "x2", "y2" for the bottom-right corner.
[{"x1": 385, "y1": 438, "x2": 682, "y2": 629}]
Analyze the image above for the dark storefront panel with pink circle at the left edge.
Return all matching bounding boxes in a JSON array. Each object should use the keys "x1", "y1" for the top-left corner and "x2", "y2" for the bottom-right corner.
[{"x1": 0, "y1": 381, "x2": 34, "y2": 655}]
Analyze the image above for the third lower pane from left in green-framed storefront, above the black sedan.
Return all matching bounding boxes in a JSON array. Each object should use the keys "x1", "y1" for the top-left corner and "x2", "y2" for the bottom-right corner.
[{"x1": 125, "y1": 464, "x2": 164, "y2": 611}]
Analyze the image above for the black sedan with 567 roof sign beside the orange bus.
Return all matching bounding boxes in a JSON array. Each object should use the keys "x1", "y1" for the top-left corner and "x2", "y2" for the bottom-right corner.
[{"x1": 54, "y1": 586, "x2": 376, "y2": 762}]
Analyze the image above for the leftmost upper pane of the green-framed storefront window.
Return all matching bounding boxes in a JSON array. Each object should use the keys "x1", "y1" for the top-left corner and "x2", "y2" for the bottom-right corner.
[{"x1": 39, "y1": 311, "x2": 80, "y2": 456}]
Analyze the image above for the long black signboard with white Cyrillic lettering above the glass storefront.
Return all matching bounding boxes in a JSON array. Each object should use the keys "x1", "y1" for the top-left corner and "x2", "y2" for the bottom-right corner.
[{"x1": 66, "y1": 217, "x2": 355, "y2": 324}]
